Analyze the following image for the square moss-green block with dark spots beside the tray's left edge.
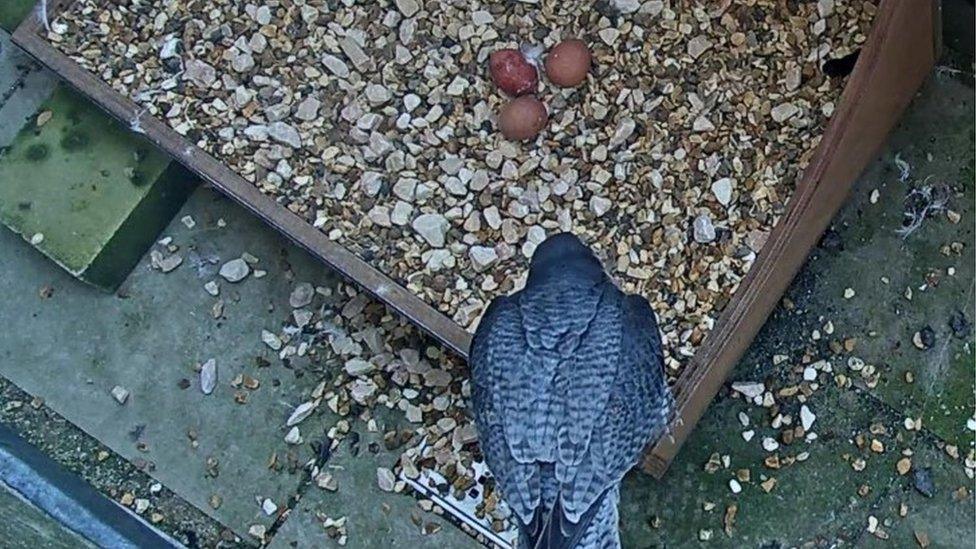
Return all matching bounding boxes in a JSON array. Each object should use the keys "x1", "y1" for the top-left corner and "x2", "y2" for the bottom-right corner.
[{"x1": 0, "y1": 87, "x2": 193, "y2": 289}]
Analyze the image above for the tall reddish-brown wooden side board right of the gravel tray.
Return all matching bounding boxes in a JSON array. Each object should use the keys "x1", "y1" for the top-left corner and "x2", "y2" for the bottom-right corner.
[{"x1": 642, "y1": 0, "x2": 938, "y2": 477}]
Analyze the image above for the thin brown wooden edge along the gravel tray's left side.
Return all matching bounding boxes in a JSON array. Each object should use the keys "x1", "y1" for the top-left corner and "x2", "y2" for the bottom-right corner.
[{"x1": 13, "y1": 0, "x2": 471, "y2": 358}]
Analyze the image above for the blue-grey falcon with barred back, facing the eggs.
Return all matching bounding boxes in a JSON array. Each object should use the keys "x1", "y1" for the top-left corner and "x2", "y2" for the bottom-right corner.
[{"x1": 469, "y1": 233, "x2": 674, "y2": 549}]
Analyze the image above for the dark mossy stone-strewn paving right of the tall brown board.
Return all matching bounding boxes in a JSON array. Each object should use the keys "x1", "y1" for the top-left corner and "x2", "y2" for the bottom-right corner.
[{"x1": 621, "y1": 77, "x2": 976, "y2": 548}]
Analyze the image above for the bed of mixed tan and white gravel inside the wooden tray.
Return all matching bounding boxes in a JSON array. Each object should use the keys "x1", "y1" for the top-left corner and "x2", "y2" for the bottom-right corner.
[{"x1": 48, "y1": 0, "x2": 876, "y2": 376}]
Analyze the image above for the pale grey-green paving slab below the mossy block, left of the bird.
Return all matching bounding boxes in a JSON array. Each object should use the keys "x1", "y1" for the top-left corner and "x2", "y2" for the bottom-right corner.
[{"x1": 0, "y1": 187, "x2": 344, "y2": 534}]
